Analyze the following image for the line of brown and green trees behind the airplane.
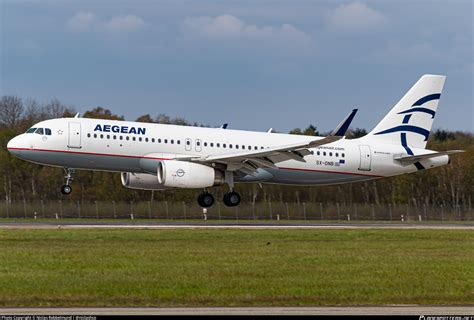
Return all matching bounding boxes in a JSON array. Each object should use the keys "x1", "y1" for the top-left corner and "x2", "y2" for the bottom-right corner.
[{"x1": 0, "y1": 95, "x2": 474, "y2": 207}]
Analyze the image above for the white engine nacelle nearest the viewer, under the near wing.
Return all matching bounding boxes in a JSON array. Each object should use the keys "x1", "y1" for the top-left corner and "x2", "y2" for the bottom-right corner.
[{"x1": 157, "y1": 160, "x2": 224, "y2": 189}]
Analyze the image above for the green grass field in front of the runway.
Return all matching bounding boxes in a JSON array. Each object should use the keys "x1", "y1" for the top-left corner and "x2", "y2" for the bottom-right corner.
[{"x1": 0, "y1": 229, "x2": 474, "y2": 307}]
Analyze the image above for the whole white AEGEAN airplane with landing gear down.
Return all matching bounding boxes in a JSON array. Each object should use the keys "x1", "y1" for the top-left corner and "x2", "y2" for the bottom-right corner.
[{"x1": 7, "y1": 74, "x2": 463, "y2": 208}]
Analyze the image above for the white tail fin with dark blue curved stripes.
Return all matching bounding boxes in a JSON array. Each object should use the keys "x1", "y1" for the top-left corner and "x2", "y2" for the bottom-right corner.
[{"x1": 367, "y1": 74, "x2": 446, "y2": 149}]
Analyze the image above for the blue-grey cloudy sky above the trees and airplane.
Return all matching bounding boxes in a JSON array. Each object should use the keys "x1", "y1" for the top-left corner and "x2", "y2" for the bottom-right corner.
[{"x1": 0, "y1": 0, "x2": 474, "y2": 132}]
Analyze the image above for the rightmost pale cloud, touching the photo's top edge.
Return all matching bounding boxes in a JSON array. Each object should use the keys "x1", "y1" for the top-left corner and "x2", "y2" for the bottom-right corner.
[{"x1": 326, "y1": 2, "x2": 387, "y2": 33}]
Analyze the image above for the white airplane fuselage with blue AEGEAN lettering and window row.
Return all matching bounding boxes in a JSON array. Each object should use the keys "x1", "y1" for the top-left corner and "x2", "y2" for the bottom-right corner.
[{"x1": 8, "y1": 118, "x2": 448, "y2": 185}]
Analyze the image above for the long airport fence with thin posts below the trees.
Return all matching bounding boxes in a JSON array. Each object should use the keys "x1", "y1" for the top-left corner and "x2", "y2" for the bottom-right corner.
[{"x1": 0, "y1": 200, "x2": 474, "y2": 221}]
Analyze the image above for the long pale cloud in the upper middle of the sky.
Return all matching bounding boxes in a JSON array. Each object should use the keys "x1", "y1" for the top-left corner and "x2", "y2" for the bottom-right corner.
[{"x1": 182, "y1": 14, "x2": 311, "y2": 42}]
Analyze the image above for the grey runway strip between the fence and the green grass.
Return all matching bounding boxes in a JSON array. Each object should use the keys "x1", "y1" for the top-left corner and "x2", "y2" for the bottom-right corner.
[{"x1": 0, "y1": 220, "x2": 474, "y2": 230}]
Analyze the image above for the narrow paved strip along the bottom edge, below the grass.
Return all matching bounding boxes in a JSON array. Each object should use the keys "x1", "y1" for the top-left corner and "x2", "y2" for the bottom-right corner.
[{"x1": 0, "y1": 305, "x2": 474, "y2": 316}]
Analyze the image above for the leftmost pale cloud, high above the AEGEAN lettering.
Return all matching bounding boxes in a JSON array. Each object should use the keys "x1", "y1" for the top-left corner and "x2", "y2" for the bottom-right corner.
[{"x1": 67, "y1": 11, "x2": 145, "y2": 34}]
